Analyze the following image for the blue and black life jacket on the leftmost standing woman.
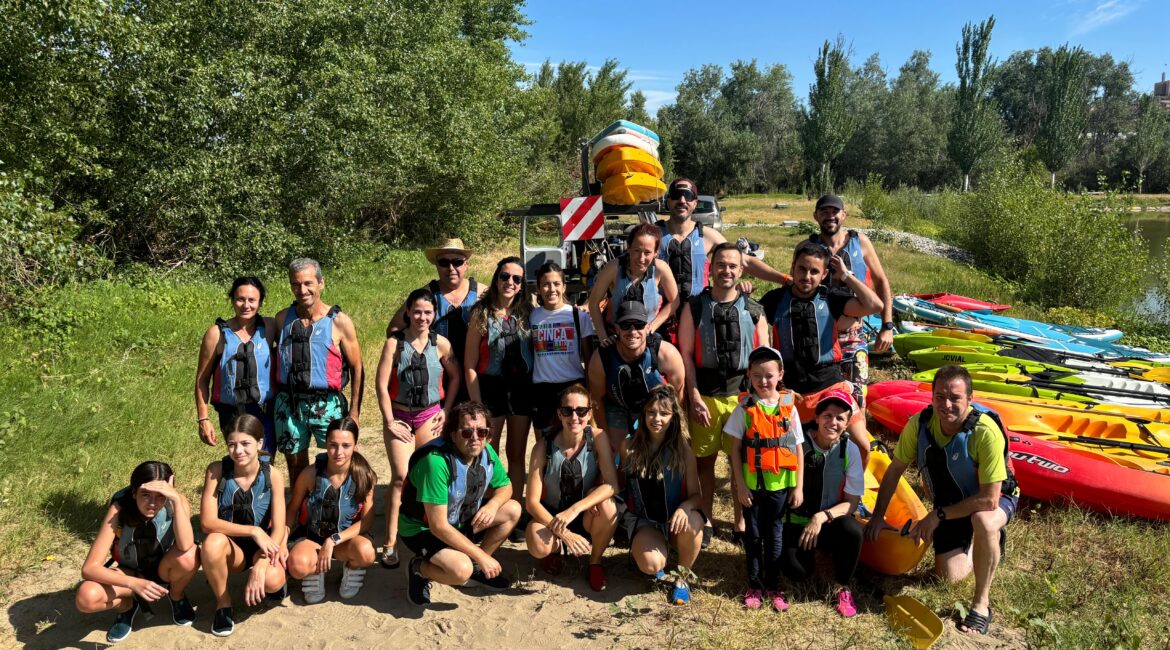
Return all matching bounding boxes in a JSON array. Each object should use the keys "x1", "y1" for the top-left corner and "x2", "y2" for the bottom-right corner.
[{"x1": 212, "y1": 316, "x2": 273, "y2": 407}]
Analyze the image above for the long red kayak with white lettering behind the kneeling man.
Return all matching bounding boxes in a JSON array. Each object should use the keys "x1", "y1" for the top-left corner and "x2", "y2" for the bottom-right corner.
[{"x1": 867, "y1": 393, "x2": 1170, "y2": 519}]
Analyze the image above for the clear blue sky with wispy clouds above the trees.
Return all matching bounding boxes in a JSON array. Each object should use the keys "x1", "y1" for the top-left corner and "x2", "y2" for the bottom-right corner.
[{"x1": 512, "y1": 0, "x2": 1170, "y2": 112}]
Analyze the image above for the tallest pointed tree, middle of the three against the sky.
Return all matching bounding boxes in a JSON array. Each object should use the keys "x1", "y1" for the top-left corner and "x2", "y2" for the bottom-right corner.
[{"x1": 947, "y1": 16, "x2": 1000, "y2": 192}]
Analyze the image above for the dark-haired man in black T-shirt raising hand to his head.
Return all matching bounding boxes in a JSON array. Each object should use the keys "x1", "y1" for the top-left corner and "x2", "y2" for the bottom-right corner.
[{"x1": 761, "y1": 242, "x2": 881, "y2": 465}]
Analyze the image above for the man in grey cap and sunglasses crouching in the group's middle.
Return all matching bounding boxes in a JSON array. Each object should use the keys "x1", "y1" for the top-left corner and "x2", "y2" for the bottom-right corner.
[{"x1": 589, "y1": 302, "x2": 686, "y2": 449}]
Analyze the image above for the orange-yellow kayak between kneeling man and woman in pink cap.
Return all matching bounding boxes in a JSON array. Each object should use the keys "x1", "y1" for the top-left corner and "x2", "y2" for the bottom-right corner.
[{"x1": 856, "y1": 441, "x2": 927, "y2": 575}]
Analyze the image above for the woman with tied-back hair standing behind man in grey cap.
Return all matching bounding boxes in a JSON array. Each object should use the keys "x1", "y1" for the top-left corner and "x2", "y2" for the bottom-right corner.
[{"x1": 589, "y1": 223, "x2": 679, "y2": 347}]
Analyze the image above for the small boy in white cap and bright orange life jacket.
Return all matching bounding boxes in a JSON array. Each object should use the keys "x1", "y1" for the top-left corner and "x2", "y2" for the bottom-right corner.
[{"x1": 723, "y1": 346, "x2": 804, "y2": 611}]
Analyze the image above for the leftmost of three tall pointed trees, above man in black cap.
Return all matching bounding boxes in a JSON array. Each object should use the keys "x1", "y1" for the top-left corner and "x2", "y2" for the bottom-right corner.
[{"x1": 800, "y1": 36, "x2": 856, "y2": 194}]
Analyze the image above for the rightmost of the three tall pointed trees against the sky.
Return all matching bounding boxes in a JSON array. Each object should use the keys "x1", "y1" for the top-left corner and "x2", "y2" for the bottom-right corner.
[{"x1": 1035, "y1": 46, "x2": 1089, "y2": 188}]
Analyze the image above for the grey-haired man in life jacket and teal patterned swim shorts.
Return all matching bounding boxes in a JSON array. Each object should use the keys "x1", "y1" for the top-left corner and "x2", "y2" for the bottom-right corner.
[{"x1": 273, "y1": 257, "x2": 365, "y2": 477}]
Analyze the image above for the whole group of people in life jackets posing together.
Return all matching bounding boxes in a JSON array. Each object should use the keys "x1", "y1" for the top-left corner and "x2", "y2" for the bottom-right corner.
[{"x1": 77, "y1": 179, "x2": 1011, "y2": 642}]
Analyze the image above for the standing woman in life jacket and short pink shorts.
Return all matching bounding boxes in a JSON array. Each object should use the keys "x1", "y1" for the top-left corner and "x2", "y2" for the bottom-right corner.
[{"x1": 374, "y1": 288, "x2": 462, "y2": 568}]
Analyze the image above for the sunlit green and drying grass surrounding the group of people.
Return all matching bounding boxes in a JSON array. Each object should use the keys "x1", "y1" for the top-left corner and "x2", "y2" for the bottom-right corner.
[{"x1": 0, "y1": 210, "x2": 1170, "y2": 648}]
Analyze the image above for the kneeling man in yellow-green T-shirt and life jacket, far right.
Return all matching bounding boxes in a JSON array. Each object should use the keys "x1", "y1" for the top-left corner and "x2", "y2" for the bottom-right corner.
[{"x1": 866, "y1": 366, "x2": 1019, "y2": 634}]
